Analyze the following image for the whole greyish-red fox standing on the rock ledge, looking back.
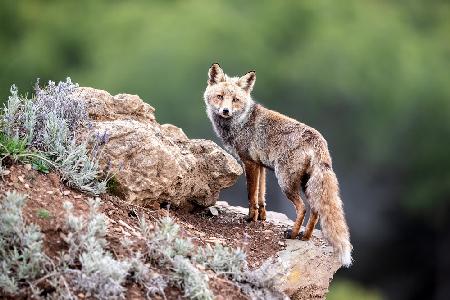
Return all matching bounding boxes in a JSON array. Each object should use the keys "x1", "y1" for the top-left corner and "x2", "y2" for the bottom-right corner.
[{"x1": 204, "y1": 64, "x2": 352, "y2": 267}]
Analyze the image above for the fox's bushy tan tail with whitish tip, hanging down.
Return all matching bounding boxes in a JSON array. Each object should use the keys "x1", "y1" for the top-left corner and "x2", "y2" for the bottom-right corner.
[{"x1": 306, "y1": 162, "x2": 353, "y2": 267}]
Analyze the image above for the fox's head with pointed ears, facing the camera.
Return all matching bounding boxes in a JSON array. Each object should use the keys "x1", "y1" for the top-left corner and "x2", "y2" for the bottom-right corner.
[{"x1": 203, "y1": 64, "x2": 256, "y2": 120}]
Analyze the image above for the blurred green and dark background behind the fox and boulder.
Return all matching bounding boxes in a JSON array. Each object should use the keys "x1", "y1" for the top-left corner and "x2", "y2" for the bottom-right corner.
[{"x1": 0, "y1": 0, "x2": 450, "y2": 299}]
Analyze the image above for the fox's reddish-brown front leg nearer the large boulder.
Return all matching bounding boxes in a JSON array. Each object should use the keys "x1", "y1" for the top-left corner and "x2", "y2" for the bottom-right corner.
[{"x1": 244, "y1": 161, "x2": 260, "y2": 222}]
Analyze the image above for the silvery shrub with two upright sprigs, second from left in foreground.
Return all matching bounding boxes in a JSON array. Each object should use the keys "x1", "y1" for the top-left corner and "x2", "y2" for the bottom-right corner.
[{"x1": 62, "y1": 199, "x2": 131, "y2": 299}]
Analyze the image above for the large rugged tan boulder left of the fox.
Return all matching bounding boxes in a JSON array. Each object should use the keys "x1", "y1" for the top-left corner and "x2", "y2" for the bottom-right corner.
[{"x1": 78, "y1": 88, "x2": 242, "y2": 207}]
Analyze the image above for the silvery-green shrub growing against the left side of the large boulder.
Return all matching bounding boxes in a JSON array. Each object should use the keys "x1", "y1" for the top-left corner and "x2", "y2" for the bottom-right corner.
[{"x1": 0, "y1": 78, "x2": 109, "y2": 195}]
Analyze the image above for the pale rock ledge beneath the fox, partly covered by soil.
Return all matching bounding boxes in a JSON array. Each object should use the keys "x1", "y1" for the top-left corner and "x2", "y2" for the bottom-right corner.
[{"x1": 216, "y1": 201, "x2": 341, "y2": 300}]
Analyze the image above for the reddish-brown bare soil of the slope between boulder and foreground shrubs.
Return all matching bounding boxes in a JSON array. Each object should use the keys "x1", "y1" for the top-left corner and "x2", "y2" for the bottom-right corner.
[{"x1": 0, "y1": 164, "x2": 283, "y2": 299}]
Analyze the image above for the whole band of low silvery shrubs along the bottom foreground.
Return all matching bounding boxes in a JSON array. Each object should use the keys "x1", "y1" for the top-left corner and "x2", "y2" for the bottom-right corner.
[{"x1": 0, "y1": 193, "x2": 285, "y2": 300}]
